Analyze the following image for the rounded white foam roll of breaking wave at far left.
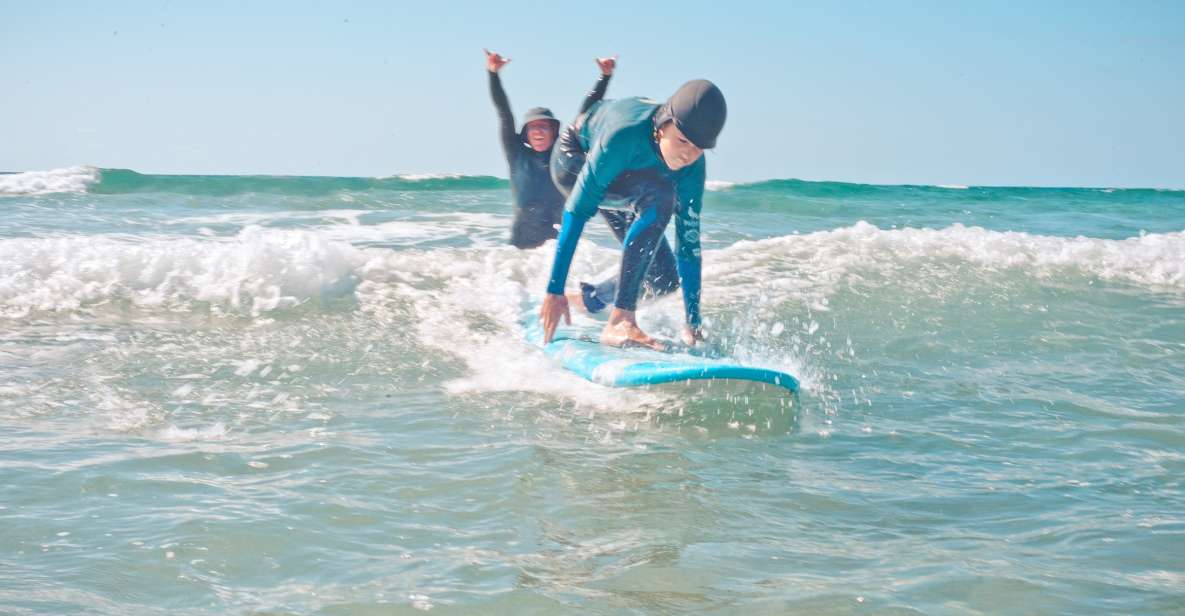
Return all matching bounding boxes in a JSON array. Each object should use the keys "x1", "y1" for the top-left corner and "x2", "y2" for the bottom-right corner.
[{"x1": 0, "y1": 227, "x2": 367, "y2": 317}]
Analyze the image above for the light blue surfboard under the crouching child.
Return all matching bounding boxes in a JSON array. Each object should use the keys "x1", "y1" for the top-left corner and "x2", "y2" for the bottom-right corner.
[{"x1": 524, "y1": 315, "x2": 799, "y2": 393}]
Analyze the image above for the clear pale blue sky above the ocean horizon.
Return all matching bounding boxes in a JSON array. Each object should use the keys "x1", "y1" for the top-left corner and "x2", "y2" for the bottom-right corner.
[{"x1": 0, "y1": 0, "x2": 1185, "y2": 187}]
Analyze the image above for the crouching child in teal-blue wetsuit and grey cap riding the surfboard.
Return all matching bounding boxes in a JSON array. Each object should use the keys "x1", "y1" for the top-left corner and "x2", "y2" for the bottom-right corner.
[{"x1": 539, "y1": 79, "x2": 728, "y2": 349}]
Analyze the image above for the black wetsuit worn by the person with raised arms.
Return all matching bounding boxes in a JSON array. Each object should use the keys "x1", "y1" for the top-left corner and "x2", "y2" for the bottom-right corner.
[{"x1": 489, "y1": 72, "x2": 609, "y2": 249}]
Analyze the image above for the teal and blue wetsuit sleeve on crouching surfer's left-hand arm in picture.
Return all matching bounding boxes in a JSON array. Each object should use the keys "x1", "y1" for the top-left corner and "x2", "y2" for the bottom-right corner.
[{"x1": 547, "y1": 132, "x2": 630, "y2": 295}]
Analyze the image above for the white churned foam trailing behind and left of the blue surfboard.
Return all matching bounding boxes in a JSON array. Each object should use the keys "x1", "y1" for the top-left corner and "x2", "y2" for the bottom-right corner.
[{"x1": 356, "y1": 243, "x2": 656, "y2": 417}]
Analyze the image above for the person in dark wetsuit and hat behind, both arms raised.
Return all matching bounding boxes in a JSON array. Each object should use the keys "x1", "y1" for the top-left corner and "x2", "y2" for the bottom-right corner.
[{"x1": 485, "y1": 50, "x2": 617, "y2": 249}]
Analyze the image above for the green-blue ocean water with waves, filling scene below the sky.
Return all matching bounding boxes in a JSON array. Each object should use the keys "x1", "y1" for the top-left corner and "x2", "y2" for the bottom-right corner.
[{"x1": 0, "y1": 167, "x2": 1185, "y2": 616}]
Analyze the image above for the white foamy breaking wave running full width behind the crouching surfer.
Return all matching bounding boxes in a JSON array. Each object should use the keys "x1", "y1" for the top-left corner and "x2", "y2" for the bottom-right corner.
[{"x1": 0, "y1": 220, "x2": 1185, "y2": 331}]
